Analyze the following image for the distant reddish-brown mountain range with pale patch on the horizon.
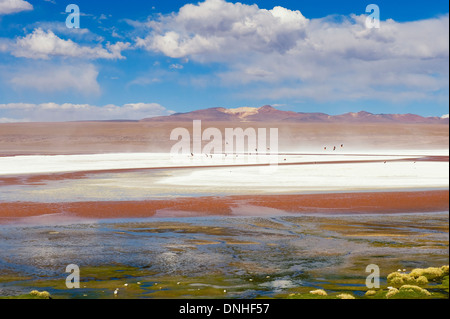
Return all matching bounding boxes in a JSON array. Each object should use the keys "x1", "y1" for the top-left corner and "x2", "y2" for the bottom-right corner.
[{"x1": 141, "y1": 105, "x2": 449, "y2": 124}]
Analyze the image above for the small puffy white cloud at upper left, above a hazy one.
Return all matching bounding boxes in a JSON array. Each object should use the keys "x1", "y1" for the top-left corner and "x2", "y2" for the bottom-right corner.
[{"x1": 10, "y1": 28, "x2": 130, "y2": 59}]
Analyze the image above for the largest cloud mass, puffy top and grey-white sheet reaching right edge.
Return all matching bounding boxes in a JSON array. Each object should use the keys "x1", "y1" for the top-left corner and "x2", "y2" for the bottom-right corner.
[{"x1": 136, "y1": 0, "x2": 449, "y2": 101}]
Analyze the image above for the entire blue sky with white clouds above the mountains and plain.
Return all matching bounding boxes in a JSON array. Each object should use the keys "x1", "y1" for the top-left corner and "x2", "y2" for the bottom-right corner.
[{"x1": 0, "y1": 0, "x2": 449, "y2": 123}]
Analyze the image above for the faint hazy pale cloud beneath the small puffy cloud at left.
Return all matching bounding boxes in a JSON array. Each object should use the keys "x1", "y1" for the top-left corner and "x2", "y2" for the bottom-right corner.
[{"x1": 9, "y1": 64, "x2": 100, "y2": 95}]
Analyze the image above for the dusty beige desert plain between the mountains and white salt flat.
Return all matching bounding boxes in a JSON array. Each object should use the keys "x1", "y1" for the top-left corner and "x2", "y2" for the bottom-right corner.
[{"x1": 0, "y1": 121, "x2": 449, "y2": 156}]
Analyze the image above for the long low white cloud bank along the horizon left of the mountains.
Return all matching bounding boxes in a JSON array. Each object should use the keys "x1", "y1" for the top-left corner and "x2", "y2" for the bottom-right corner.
[{"x1": 0, "y1": 103, "x2": 173, "y2": 123}]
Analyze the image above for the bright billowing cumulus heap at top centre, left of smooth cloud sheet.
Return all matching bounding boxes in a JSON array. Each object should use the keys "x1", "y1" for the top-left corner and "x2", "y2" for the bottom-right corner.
[{"x1": 137, "y1": 0, "x2": 308, "y2": 60}]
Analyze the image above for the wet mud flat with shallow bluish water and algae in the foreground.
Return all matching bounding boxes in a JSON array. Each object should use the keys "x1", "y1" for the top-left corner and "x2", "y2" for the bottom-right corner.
[{"x1": 0, "y1": 212, "x2": 449, "y2": 299}]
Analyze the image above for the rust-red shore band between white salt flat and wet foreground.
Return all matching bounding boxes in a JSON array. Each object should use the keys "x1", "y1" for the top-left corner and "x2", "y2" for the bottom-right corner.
[{"x1": 0, "y1": 190, "x2": 449, "y2": 223}]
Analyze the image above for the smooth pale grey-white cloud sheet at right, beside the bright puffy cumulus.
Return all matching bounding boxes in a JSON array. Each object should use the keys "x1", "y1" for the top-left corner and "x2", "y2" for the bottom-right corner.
[{"x1": 223, "y1": 16, "x2": 448, "y2": 101}]
